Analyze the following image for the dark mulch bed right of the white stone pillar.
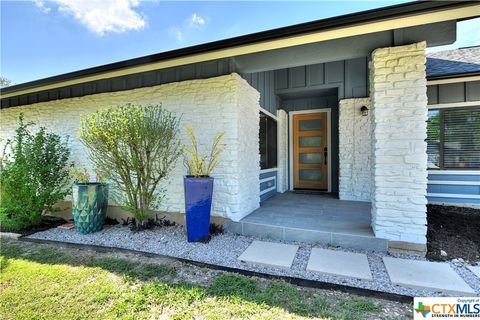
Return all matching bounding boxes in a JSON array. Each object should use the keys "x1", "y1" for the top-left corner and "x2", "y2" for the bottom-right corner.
[{"x1": 427, "y1": 205, "x2": 480, "y2": 262}]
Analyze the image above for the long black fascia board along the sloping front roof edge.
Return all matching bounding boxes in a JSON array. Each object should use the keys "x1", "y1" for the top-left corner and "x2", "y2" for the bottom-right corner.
[{"x1": 1, "y1": 1, "x2": 472, "y2": 94}]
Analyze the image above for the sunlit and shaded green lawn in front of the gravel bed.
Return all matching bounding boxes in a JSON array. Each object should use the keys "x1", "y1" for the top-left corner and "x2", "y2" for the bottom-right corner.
[{"x1": 0, "y1": 242, "x2": 390, "y2": 319}]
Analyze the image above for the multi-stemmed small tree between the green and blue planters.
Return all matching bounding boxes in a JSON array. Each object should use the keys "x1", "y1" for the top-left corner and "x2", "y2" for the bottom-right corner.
[{"x1": 79, "y1": 104, "x2": 181, "y2": 226}]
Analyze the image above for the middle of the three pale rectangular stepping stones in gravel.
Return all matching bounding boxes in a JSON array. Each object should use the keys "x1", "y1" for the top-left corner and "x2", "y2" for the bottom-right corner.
[{"x1": 307, "y1": 248, "x2": 373, "y2": 280}]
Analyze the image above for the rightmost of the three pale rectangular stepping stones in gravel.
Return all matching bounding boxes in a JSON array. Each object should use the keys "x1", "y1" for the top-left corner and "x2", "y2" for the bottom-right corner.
[{"x1": 383, "y1": 257, "x2": 476, "y2": 295}]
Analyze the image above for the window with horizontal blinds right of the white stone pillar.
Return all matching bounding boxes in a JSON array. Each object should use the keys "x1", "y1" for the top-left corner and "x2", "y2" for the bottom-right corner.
[{"x1": 426, "y1": 107, "x2": 480, "y2": 169}]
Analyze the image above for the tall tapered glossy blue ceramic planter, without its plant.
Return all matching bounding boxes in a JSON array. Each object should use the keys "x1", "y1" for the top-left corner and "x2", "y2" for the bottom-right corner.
[{"x1": 183, "y1": 177, "x2": 213, "y2": 242}]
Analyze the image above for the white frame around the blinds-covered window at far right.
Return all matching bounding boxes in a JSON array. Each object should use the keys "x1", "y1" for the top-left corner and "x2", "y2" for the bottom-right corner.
[{"x1": 425, "y1": 105, "x2": 480, "y2": 171}]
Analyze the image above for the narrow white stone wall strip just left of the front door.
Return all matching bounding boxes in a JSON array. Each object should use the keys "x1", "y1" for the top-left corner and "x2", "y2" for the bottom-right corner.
[{"x1": 277, "y1": 109, "x2": 288, "y2": 193}]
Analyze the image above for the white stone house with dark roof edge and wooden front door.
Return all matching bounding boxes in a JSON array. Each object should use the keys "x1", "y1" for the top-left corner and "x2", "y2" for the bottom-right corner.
[{"x1": 0, "y1": 2, "x2": 480, "y2": 251}]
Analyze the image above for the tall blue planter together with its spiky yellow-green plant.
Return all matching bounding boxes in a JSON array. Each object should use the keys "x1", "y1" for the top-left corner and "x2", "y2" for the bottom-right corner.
[{"x1": 183, "y1": 127, "x2": 224, "y2": 242}]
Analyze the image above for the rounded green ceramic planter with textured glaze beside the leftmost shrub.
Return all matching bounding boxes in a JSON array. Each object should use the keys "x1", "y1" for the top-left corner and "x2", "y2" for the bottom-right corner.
[{"x1": 72, "y1": 183, "x2": 108, "y2": 234}]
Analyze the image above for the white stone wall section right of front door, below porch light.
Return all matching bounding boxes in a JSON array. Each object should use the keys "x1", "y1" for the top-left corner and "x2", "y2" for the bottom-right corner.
[{"x1": 338, "y1": 98, "x2": 372, "y2": 201}]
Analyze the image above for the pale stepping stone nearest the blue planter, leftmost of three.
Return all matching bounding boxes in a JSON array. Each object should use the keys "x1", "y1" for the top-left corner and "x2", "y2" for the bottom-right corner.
[{"x1": 238, "y1": 241, "x2": 298, "y2": 268}]
